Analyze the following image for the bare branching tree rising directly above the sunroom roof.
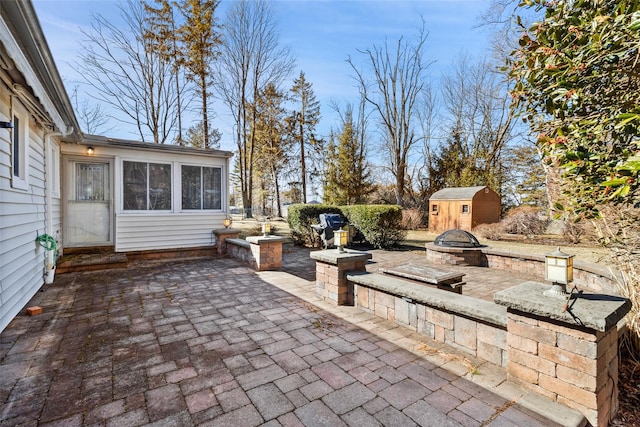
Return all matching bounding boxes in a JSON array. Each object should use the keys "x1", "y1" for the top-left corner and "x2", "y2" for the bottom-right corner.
[{"x1": 78, "y1": 0, "x2": 177, "y2": 144}]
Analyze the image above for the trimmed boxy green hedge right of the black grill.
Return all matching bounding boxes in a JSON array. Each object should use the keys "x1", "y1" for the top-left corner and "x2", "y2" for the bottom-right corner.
[{"x1": 340, "y1": 205, "x2": 406, "y2": 249}]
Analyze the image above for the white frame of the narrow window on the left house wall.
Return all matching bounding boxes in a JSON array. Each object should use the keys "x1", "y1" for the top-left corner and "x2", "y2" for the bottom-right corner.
[{"x1": 11, "y1": 101, "x2": 31, "y2": 190}]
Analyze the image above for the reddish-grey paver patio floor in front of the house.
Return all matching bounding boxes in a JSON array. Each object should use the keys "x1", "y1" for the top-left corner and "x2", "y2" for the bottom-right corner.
[{"x1": 0, "y1": 251, "x2": 576, "y2": 427}]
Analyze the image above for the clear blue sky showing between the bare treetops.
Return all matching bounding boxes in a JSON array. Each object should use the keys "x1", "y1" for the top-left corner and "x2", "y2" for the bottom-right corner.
[{"x1": 33, "y1": 0, "x2": 489, "y2": 150}]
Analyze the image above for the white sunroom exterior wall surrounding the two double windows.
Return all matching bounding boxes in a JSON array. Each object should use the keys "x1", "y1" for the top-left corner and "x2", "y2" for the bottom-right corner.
[{"x1": 62, "y1": 144, "x2": 228, "y2": 252}]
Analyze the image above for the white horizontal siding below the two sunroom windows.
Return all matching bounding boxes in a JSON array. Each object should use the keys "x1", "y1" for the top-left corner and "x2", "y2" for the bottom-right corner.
[{"x1": 115, "y1": 213, "x2": 224, "y2": 252}]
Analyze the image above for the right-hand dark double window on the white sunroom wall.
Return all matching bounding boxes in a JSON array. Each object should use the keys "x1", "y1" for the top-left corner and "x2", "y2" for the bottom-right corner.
[{"x1": 182, "y1": 165, "x2": 222, "y2": 210}]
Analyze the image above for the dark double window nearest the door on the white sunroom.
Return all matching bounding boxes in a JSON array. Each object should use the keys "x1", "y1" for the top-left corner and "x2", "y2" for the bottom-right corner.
[{"x1": 122, "y1": 161, "x2": 171, "y2": 211}]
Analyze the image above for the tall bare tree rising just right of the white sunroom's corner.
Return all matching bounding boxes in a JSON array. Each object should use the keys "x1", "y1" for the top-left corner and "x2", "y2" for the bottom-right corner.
[{"x1": 216, "y1": 0, "x2": 294, "y2": 219}]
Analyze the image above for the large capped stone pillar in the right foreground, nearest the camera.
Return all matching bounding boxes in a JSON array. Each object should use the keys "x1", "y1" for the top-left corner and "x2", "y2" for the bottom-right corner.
[{"x1": 494, "y1": 282, "x2": 631, "y2": 427}]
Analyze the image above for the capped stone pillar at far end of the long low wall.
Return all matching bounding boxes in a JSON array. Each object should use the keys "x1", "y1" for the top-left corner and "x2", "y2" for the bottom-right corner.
[{"x1": 311, "y1": 249, "x2": 371, "y2": 305}]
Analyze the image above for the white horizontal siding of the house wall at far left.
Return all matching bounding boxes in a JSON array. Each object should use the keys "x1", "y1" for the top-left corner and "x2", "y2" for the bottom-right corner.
[{"x1": 0, "y1": 122, "x2": 47, "y2": 330}]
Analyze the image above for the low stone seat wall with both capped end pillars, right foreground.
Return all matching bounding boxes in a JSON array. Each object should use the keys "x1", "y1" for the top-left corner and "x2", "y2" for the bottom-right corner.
[{"x1": 311, "y1": 251, "x2": 631, "y2": 427}]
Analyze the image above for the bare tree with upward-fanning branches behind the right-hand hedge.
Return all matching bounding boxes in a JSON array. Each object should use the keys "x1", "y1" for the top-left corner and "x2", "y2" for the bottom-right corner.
[{"x1": 347, "y1": 19, "x2": 433, "y2": 206}]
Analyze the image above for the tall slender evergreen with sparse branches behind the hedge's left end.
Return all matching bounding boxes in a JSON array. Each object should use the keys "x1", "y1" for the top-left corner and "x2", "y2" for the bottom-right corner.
[{"x1": 290, "y1": 71, "x2": 322, "y2": 203}]
